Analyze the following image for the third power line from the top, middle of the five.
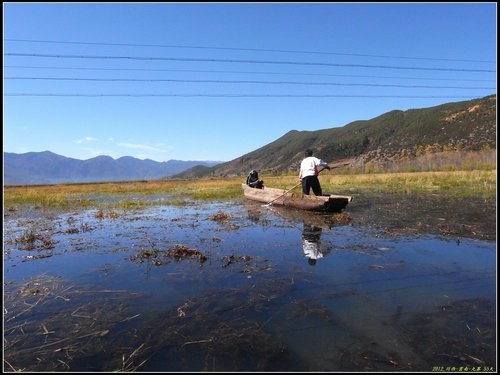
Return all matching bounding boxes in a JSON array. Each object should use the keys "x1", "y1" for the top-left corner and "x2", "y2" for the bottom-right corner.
[{"x1": 4, "y1": 65, "x2": 495, "y2": 82}]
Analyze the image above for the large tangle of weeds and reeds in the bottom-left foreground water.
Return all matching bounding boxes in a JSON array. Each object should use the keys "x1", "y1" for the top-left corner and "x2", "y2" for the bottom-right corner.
[{"x1": 4, "y1": 275, "x2": 304, "y2": 372}]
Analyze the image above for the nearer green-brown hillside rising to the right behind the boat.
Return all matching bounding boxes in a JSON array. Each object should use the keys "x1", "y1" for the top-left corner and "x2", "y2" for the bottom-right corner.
[{"x1": 176, "y1": 95, "x2": 497, "y2": 177}]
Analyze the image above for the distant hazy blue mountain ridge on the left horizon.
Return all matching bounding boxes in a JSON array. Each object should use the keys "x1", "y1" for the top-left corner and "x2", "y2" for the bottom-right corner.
[{"x1": 4, "y1": 151, "x2": 221, "y2": 185}]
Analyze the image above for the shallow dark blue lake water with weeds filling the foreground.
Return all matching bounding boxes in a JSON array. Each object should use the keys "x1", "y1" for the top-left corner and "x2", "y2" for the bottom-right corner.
[{"x1": 4, "y1": 195, "x2": 496, "y2": 372}]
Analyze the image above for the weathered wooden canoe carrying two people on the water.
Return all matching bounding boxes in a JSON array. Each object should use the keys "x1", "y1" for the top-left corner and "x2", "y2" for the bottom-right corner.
[{"x1": 241, "y1": 184, "x2": 352, "y2": 212}]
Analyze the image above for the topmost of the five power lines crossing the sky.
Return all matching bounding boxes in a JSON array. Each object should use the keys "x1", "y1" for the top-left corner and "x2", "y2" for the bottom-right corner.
[{"x1": 4, "y1": 38, "x2": 495, "y2": 63}]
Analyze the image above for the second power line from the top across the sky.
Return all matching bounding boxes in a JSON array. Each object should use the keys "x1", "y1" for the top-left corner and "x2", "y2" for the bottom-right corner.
[{"x1": 4, "y1": 53, "x2": 495, "y2": 73}]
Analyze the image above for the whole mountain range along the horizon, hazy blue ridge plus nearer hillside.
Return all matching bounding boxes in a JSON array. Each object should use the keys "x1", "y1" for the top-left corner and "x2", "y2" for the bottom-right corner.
[{"x1": 4, "y1": 95, "x2": 496, "y2": 185}]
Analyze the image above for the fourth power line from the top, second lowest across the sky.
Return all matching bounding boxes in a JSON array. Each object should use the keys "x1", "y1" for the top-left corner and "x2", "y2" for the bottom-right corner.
[{"x1": 4, "y1": 77, "x2": 495, "y2": 90}]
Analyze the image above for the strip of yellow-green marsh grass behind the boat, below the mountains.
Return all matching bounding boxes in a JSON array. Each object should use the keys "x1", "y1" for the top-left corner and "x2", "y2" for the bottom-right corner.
[{"x1": 4, "y1": 170, "x2": 496, "y2": 209}]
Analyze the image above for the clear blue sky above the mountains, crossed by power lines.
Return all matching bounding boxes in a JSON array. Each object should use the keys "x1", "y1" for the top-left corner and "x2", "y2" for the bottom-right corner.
[{"x1": 3, "y1": 2, "x2": 497, "y2": 161}]
